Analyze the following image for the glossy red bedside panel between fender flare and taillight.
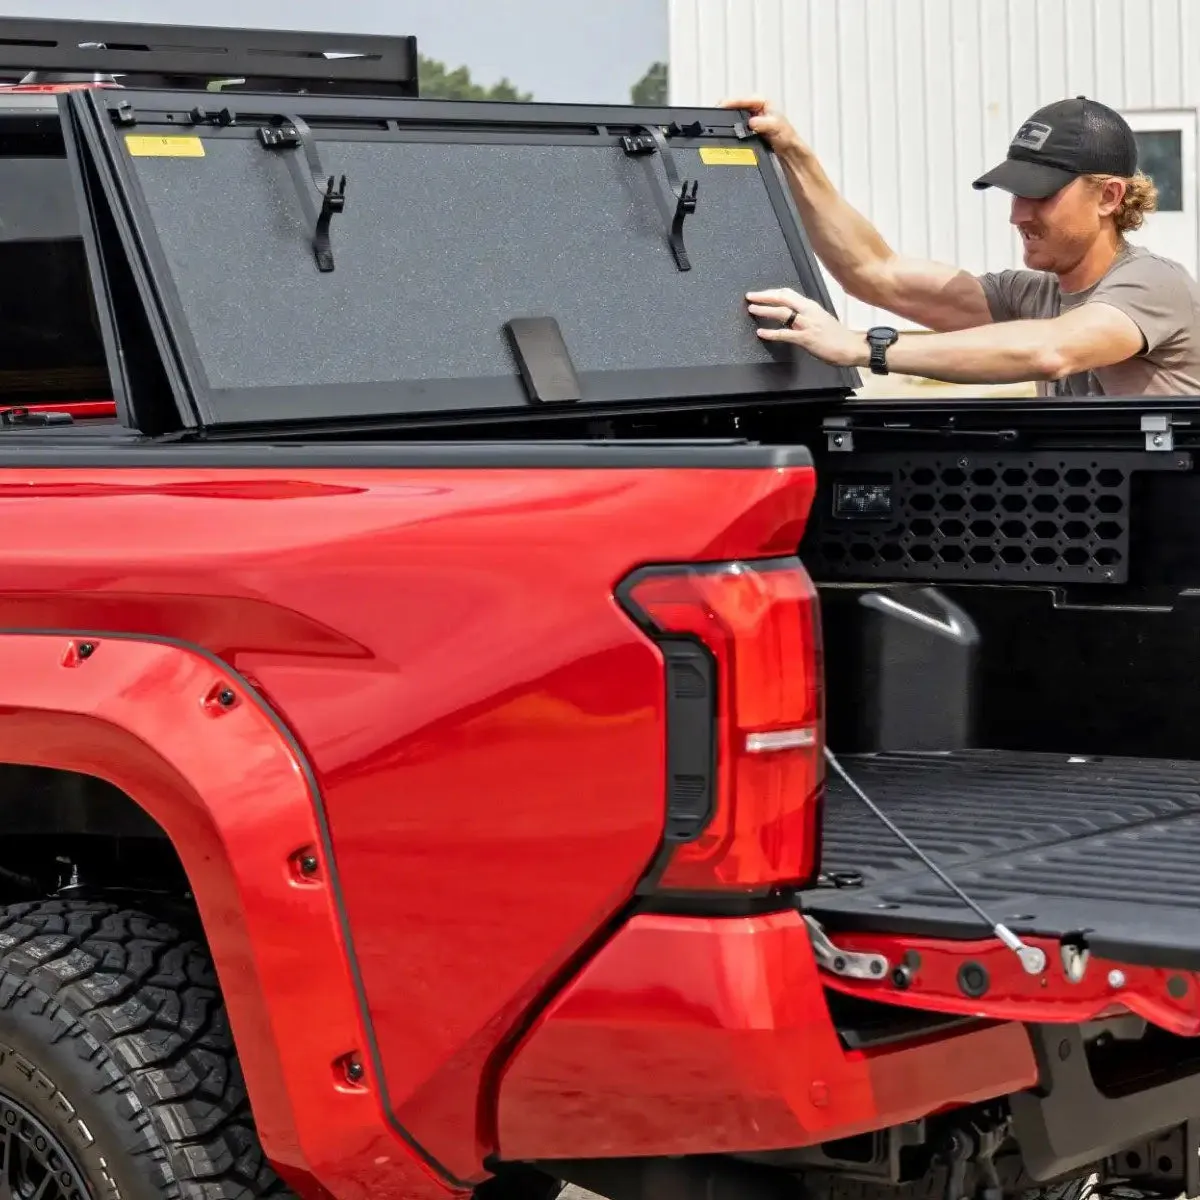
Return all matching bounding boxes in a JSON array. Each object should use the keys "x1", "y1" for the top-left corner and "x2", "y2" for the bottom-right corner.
[{"x1": 0, "y1": 468, "x2": 814, "y2": 1195}]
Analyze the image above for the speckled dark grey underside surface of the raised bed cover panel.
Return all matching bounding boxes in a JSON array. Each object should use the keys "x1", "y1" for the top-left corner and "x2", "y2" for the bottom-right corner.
[{"x1": 133, "y1": 139, "x2": 796, "y2": 388}]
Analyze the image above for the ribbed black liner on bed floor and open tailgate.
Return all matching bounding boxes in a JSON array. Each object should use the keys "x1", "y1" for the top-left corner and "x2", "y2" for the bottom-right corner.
[{"x1": 804, "y1": 750, "x2": 1200, "y2": 968}]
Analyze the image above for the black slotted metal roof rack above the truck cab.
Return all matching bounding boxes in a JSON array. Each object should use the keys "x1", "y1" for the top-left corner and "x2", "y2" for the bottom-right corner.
[{"x1": 0, "y1": 17, "x2": 419, "y2": 97}]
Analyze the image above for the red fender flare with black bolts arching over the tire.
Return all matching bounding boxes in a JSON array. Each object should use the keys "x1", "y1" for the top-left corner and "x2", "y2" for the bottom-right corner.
[{"x1": 0, "y1": 631, "x2": 458, "y2": 1194}]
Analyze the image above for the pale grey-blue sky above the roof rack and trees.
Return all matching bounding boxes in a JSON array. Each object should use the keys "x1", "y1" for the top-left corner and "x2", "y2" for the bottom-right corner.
[{"x1": 11, "y1": 0, "x2": 667, "y2": 104}]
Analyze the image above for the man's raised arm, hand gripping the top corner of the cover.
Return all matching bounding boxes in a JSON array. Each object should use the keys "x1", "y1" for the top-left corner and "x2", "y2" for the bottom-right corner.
[{"x1": 725, "y1": 97, "x2": 992, "y2": 330}]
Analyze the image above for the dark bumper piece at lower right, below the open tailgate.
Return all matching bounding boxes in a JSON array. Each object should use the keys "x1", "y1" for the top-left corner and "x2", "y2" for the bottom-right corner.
[{"x1": 1008, "y1": 1025, "x2": 1200, "y2": 1182}]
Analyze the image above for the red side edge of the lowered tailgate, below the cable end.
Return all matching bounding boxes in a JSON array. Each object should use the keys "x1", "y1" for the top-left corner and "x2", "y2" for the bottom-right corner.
[{"x1": 829, "y1": 934, "x2": 1200, "y2": 1038}]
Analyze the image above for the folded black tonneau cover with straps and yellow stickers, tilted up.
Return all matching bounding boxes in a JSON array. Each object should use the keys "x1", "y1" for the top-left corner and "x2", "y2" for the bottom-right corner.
[{"x1": 62, "y1": 89, "x2": 857, "y2": 428}]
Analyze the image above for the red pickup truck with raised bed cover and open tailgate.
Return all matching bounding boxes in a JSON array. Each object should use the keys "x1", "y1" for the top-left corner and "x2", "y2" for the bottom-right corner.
[{"x1": 0, "y1": 20, "x2": 1200, "y2": 1200}]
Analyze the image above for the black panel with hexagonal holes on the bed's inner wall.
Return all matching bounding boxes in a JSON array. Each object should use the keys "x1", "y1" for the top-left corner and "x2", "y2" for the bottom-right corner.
[{"x1": 803, "y1": 451, "x2": 1180, "y2": 583}]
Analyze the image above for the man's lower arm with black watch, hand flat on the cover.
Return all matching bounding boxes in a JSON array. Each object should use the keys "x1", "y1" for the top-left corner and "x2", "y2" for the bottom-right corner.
[{"x1": 746, "y1": 288, "x2": 1145, "y2": 383}]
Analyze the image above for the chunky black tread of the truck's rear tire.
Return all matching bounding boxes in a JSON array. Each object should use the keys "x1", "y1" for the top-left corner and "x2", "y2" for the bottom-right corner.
[{"x1": 0, "y1": 900, "x2": 293, "y2": 1200}]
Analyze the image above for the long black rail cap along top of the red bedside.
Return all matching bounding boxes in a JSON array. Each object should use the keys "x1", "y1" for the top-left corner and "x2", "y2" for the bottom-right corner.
[{"x1": 0, "y1": 441, "x2": 812, "y2": 470}]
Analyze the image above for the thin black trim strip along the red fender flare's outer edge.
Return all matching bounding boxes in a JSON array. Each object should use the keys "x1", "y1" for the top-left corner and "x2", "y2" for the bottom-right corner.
[{"x1": 0, "y1": 629, "x2": 472, "y2": 1190}]
